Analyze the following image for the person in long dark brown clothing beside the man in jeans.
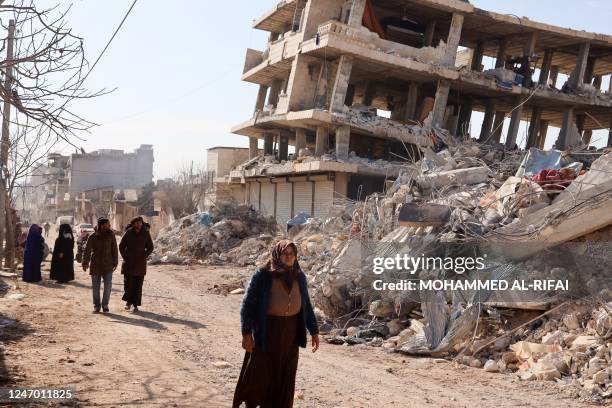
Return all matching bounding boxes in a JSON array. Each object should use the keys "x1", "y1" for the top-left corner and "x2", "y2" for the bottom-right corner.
[{"x1": 119, "y1": 217, "x2": 153, "y2": 312}]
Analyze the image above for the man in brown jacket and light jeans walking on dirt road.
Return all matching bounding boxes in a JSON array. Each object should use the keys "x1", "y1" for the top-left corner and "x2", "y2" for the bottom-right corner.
[{"x1": 83, "y1": 217, "x2": 119, "y2": 313}]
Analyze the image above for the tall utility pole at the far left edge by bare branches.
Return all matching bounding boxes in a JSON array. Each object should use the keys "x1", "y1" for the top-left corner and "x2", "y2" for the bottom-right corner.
[{"x1": 0, "y1": 20, "x2": 15, "y2": 268}]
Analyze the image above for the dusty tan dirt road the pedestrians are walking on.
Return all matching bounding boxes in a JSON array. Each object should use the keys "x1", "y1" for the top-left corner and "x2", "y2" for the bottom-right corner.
[{"x1": 0, "y1": 266, "x2": 586, "y2": 408}]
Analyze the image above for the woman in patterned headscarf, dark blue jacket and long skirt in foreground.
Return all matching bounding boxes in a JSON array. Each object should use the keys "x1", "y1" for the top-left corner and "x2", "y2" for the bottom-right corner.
[{"x1": 233, "y1": 240, "x2": 319, "y2": 408}]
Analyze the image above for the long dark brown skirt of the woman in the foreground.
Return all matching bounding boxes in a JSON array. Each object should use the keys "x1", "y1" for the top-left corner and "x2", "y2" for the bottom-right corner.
[{"x1": 233, "y1": 314, "x2": 299, "y2": 408}]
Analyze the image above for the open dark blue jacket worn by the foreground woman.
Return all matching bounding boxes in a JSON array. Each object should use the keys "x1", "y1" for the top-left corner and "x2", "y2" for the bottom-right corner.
[{"x1": 240, "y1": 268, "x2": 319, "y2": 350}]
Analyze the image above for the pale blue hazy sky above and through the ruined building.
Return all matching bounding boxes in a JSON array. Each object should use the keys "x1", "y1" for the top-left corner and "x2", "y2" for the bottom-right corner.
[{"x1": 40, "y1": 0, "x2": 612, "y2": 179}]
